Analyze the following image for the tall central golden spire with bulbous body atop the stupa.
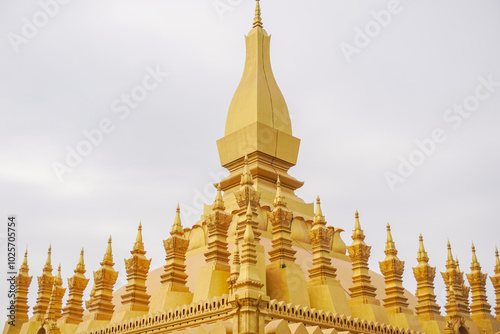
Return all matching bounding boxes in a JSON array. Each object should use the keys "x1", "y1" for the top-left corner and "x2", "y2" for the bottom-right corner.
[{"x1": 217, "y1": 1, "x2": 303, "y2": 198}]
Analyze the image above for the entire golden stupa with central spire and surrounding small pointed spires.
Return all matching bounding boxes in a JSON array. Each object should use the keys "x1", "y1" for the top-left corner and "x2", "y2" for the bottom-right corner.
[{"x1": 3, "y1": 0, "x2": 500, "y2": 334}]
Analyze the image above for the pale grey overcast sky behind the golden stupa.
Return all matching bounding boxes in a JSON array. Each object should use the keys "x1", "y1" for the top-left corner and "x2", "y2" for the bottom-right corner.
[{"x1": 0, "y1": 0, "x2": 500, "y2": 324}]
